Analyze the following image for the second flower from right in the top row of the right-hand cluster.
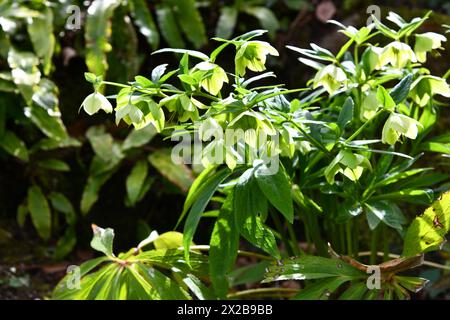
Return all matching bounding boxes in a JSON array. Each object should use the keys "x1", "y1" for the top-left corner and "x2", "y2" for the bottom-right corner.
[{"x1": 377, "y1": 41, "x2": 417, "y2": 69}]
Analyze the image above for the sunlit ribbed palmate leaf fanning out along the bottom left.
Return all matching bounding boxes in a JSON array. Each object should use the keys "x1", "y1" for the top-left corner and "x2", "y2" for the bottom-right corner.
[{"x1": 52, "y1": 227, "x2": 215, "y2": 300}]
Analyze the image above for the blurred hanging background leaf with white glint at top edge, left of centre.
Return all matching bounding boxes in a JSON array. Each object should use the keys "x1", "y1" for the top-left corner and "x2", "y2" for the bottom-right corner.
[{"x1": 130, "y1": 0, "x2": 159, "y2": 49}]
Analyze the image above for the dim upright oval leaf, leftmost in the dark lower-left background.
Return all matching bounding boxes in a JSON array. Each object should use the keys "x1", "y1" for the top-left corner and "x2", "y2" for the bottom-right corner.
[{"x1": 27, "y1": 185, "x2": 51, "y2": 240}]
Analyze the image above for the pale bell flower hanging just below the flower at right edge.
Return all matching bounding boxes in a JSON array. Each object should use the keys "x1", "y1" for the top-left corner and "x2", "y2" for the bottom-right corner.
[{"x1": 381, "y1": 113, "x2": 422, "y2": 145}]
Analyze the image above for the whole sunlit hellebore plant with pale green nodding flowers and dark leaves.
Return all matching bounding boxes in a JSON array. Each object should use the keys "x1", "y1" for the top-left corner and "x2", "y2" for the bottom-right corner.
[{"x1": 54, "y1": 12, "x2": 450, "y2": 299}]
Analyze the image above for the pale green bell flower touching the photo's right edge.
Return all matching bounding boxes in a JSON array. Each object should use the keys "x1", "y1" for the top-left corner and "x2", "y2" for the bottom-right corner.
[{"x1": 410, "y1": 75, "x2": 450, "y2": 107}]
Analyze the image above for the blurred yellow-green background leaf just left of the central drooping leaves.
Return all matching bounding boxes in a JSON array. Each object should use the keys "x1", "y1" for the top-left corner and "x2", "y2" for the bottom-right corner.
[{"x1": 148, "y1": 149, "x2": 193, "y2": 192}]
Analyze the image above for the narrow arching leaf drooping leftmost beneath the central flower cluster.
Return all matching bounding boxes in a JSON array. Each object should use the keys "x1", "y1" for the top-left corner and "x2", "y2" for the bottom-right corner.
[{"x1": 183, "y1": 169, "x2": 231, "y2": 261}]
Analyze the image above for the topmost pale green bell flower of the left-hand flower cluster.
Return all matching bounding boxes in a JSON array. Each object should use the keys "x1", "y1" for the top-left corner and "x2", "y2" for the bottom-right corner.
[{"x1": 234, "y1": 41, "x2": 278, "y2": 76}]
